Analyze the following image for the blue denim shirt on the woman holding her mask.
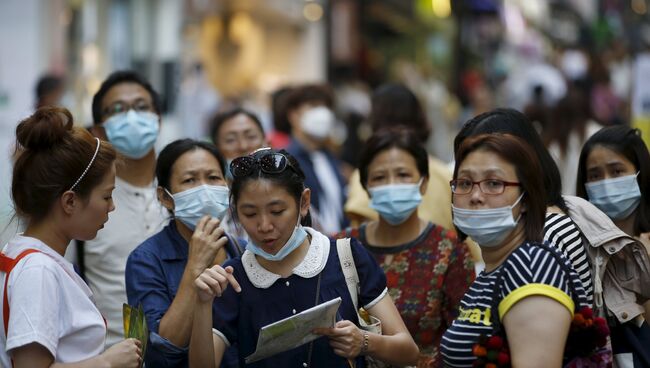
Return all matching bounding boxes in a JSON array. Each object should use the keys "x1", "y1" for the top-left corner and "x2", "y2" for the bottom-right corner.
[{"x1": 125, "y1": 221, "x2": 243, "y2": 367}]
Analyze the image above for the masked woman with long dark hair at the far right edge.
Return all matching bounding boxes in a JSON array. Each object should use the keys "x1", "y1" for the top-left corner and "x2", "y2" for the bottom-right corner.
[{"x1": 576, "y1": 126, "x2": 650, "y2": 367}]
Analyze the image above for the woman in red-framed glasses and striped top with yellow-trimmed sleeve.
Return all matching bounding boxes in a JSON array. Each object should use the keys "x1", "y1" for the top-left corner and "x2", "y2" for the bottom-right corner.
[{"x1": 441, "y1": 134, "x2": 586, "y2": 367}]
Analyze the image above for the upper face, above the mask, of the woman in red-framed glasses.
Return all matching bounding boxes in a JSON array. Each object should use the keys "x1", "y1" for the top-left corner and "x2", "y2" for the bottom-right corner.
[{"x1": 453, "y1": 149, "x2": 522, "y2": 213}]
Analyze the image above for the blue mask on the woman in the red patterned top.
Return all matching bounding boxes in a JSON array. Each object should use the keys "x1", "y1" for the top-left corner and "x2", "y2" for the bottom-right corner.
[{"x1": 368, "y1": 180, "x2": 422, "y2": 225}]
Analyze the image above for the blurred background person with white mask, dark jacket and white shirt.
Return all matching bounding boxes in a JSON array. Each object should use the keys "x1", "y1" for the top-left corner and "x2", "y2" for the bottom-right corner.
[{"x1": 286, "y1": 85, "x2": 346, "y2": 233}]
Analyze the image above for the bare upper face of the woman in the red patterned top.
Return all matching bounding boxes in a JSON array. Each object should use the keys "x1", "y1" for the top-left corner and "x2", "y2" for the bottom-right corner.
[{"x1": 366, "y1": 147, "x2": 426, "y2": 194}]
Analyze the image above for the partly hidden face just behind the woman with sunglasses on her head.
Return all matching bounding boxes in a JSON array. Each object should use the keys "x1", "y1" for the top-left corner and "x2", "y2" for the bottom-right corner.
[{"x1": 215, "y1": 114, "x2": 266, "y2": 160}]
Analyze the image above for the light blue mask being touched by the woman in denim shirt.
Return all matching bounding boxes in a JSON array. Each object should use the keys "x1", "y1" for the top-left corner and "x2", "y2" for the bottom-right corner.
[{"x1": 165, "y1": 184, "x2": 230, "y2": 230}]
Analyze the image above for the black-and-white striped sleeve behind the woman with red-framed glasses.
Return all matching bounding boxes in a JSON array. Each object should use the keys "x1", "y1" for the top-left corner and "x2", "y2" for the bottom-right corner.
[{"x1": 544, "y1": 213, "x2": 594, "y2": 306}]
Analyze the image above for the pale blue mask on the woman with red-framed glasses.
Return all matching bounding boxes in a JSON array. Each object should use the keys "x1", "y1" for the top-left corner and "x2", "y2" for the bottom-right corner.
[{"x1": 451, "y1": 193, "x2": 524, "y2": 247}]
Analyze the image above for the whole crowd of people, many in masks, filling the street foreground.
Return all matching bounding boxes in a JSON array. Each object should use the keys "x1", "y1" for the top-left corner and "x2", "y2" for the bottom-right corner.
[{"x1": 0, "y1": 71, "x2": 650, "y2": 368}]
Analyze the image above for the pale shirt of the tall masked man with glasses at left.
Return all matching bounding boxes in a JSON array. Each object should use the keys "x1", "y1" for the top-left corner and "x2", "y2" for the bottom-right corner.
[{"x1": 66, "y1": 178, "x2": 169, "y2": 347}]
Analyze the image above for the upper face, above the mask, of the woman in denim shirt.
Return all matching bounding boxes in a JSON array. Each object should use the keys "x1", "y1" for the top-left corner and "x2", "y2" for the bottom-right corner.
[{"x1": 169, "y1": 148, "x2": 226, "y2": 194}]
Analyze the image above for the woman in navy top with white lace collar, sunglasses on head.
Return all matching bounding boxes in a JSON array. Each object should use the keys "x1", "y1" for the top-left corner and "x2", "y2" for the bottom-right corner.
[{"x1": 185, "y1": 149, "x2": 418, "y2": 367}]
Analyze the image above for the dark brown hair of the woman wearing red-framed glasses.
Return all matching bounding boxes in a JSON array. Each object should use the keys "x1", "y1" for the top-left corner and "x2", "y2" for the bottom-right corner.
[{"x1": 454, "y1": 133, "x2": 546, "y2": 241}]
